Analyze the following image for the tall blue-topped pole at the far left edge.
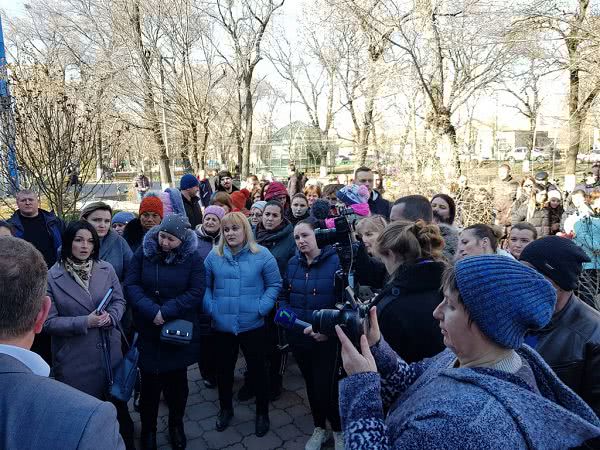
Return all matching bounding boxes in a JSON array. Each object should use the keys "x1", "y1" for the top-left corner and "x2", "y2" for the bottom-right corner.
[{"x1": 0, "y1": 17, "x2": 19, "y2": 194}]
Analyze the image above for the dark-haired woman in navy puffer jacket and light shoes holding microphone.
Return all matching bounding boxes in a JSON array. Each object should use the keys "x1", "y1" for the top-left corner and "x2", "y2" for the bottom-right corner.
[{"x1": 280, "y1": 219, "x2": 344, "y2": 449}]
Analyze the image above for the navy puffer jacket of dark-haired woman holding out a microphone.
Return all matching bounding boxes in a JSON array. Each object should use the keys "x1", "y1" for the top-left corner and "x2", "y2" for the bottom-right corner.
[{"x1": 279, "y1": 246, "x2": 340, "y2": 349}]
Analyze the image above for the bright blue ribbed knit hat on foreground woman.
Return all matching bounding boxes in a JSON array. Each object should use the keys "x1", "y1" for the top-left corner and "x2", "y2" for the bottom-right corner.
[{"x1": 455, "y1": 255, "x2": 556, "y2": 349}]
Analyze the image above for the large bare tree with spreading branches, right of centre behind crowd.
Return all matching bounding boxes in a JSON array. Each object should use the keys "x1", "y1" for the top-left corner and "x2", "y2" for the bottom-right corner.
[{"x1": 345, "y1": 0, "x2": 508, "y2": 177}]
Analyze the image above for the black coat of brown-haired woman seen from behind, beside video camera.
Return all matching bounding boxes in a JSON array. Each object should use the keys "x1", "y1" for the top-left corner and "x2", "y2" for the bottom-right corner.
[{"x1": 377, "y1": 260, "x2": 445, "y2": 363}]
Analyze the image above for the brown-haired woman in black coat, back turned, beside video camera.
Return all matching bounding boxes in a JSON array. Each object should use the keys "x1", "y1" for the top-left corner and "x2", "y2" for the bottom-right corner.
[{"x1": 375, "y1": 220, "x2": 445, "y2": 363}]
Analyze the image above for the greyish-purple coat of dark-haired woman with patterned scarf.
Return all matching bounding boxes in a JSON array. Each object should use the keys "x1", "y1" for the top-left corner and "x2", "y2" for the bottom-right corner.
[{"x1": 44, "y1": 261, "x2": 125, "y2": 399}]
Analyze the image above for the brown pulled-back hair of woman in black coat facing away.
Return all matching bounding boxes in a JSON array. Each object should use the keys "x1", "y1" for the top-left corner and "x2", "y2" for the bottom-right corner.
[{"x1": 376, "y1": 220, "x2": 445, "y2": 263}]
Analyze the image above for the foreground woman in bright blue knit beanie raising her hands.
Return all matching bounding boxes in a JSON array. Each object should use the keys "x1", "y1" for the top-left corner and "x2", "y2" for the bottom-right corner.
[{"x1": 336, "y1": 255, "x2": 600, "y2": 449}]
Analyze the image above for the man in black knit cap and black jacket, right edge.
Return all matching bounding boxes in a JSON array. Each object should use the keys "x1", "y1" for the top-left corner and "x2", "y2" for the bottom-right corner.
[{"x1": 520, "y1": 236, "x2": 600, "y2": 418}]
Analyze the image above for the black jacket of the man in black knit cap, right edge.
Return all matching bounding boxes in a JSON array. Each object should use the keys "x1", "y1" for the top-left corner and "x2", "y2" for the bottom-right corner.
[{"x1": 527, "y1": 295, "x2": 600, "y2": 417}]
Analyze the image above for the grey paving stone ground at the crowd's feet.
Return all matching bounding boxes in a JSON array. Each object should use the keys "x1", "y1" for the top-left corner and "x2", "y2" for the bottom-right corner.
[{"x1": 131, "y1": 355, "x2": 333, "y2": 450}]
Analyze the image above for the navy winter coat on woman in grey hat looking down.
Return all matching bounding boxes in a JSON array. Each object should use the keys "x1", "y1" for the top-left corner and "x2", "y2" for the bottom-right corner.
[{"x1": 125, "y1": 226, "x2": 206, "y2": 373}]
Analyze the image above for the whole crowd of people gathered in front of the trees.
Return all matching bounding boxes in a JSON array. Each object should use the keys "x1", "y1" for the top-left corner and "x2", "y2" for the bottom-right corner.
[{"x1": 0, "y1": 164, "x2": 600, "y2": 450}]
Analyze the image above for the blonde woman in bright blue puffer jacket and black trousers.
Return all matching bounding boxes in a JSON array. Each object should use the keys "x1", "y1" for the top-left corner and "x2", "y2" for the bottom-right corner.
[{"x1": 204, "y1": 212, "x2": 281, "y2": 437}]
